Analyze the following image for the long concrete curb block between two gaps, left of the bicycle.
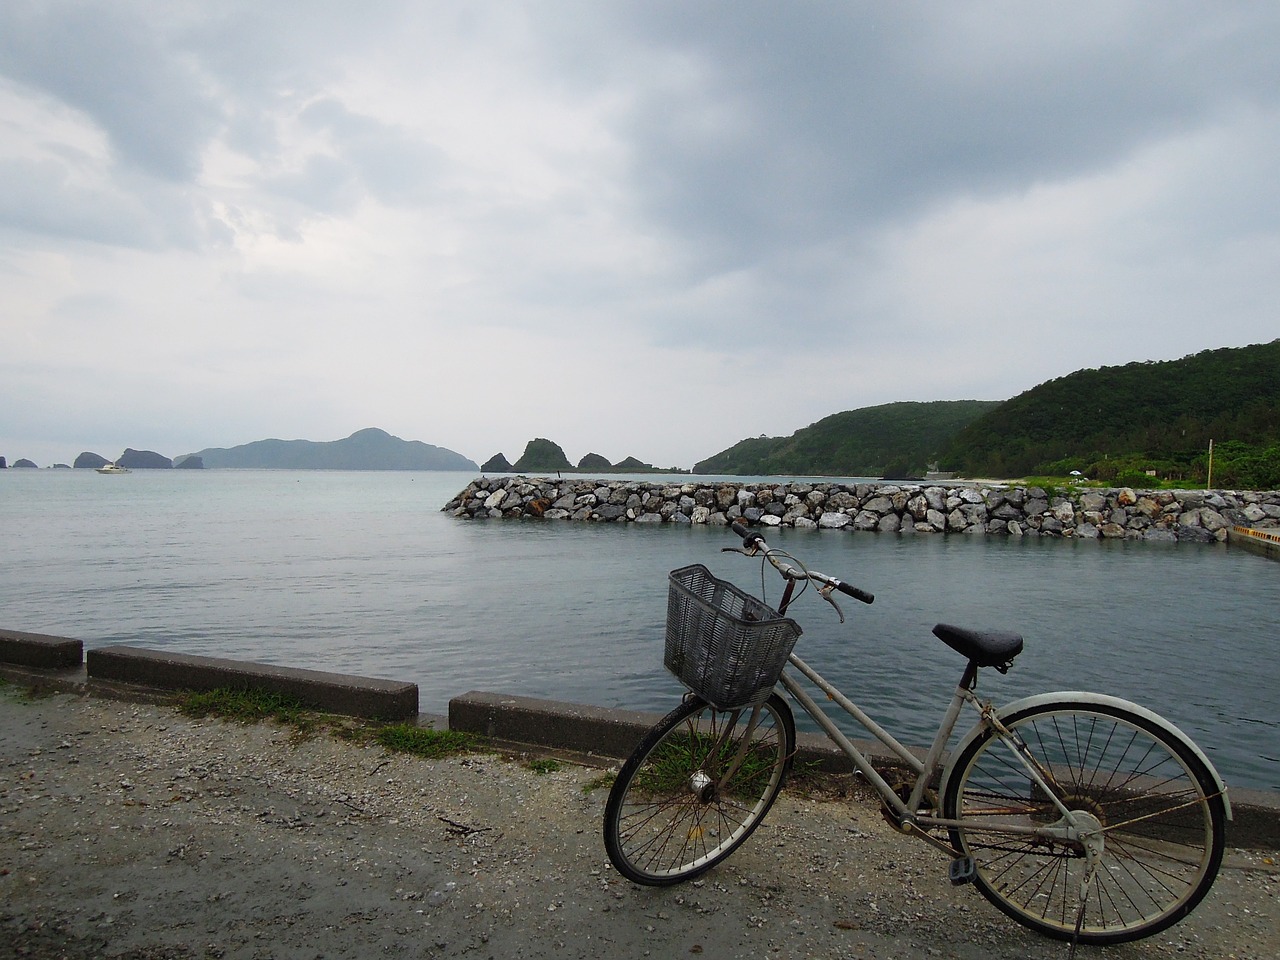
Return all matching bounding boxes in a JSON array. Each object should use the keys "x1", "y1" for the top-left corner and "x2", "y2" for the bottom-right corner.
[{"x1": 84, "y1": 645, "x2": 417, "y2": 719}]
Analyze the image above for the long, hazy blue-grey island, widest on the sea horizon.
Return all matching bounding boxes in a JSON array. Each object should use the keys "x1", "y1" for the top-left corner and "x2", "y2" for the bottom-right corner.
[{"x1": 183, "y1": 426, "x2": 480, "y2": 470}]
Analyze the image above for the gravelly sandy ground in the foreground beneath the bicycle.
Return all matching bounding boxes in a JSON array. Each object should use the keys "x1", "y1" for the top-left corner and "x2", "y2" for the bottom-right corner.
[{"x1": 0, "y1": 686, "x2": 1280, "y2": 960}]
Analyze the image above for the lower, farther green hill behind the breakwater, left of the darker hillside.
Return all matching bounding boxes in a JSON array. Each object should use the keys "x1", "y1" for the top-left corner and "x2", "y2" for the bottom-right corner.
[{"x1": 694, "y1": 401, "x2": 1000, "y2": 476}]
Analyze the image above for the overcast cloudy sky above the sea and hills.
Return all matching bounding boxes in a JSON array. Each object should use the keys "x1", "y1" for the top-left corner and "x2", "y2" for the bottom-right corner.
[{"x1": 0, "y1": 0, "x2": 1280, "y2": 467}]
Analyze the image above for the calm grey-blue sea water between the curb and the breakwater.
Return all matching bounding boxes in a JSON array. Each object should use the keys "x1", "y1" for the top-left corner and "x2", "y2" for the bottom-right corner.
[{"x1": 0, "y1": 470, "x2": 1280, "y2": 790}]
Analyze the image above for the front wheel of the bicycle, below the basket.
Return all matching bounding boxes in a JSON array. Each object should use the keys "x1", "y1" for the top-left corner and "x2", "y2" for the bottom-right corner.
[{"x1": 604, "y1": 694, "x2": 796, "y2": 886}]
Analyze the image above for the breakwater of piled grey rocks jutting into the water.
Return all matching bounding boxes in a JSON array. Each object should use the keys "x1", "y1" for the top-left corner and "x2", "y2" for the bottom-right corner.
[{"x1": 443, "y1": 476, "x2": 1280, "y2": 541}]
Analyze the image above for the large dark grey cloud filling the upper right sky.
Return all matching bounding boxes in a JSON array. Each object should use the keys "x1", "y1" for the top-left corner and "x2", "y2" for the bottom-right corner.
[{"x1": 591, "y1": 3, "x2": 1280, "y2": 259}]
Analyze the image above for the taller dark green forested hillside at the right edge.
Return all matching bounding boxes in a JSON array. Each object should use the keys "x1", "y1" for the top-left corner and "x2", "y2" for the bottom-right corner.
[{"x1": 942, "y1": 340, "x2": 1280, "y2": 489}]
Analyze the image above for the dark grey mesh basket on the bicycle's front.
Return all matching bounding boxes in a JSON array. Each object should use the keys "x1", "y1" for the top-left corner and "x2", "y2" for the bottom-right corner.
[{"x1": 663, "y1": 563, "x2": 800, "y2": 710}]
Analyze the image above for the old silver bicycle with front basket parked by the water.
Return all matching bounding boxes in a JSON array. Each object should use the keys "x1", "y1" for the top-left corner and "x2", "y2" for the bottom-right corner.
[{"x1": 604, "y1": 522, "x2": 1231, "y2": 951}]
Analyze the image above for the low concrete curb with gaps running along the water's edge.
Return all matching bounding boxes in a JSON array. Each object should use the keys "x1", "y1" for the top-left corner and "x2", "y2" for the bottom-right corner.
[{"x1": 0, "y1": 630, "x2": 1280, "y2": 850}]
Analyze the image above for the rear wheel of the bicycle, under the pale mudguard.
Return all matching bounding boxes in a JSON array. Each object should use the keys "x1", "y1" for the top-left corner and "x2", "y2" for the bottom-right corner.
[{"x1": 942, "y1": 699, "x2": 1226, "y2": 945}]
